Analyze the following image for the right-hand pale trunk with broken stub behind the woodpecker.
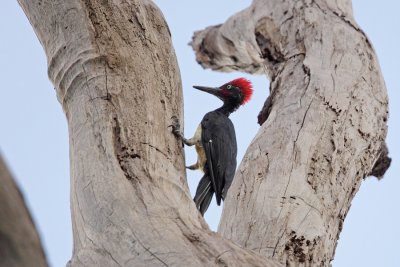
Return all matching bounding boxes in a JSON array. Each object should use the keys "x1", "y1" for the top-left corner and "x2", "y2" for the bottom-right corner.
[{"x1": 192, "y1": 0, "x2": 390, "y2": 266}]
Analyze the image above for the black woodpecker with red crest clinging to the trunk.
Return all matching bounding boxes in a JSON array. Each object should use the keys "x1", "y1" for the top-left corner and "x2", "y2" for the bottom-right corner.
[{"x1": 171, "y1": 78, "x2": 253, "y2": 216}]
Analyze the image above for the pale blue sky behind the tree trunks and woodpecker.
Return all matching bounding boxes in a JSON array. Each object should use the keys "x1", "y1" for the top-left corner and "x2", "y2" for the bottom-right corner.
[{"x1": 0, "y1": 0, "x2": 400, "y2": 267}]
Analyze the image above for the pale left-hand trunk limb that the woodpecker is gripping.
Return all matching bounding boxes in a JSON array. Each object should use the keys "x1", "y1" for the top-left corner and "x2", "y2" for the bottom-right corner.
[{"x1": 19, "y1": 0, "x2": 280, "y2": 266}]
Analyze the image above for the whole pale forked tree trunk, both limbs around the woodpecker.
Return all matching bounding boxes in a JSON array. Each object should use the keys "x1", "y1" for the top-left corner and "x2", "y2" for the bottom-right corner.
[{"x1": 19, "y1": 0, "x2": 387, "y2": 266}]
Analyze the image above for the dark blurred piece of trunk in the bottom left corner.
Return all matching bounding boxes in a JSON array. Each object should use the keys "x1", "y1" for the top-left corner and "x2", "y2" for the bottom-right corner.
[{"x1": 0, "y1": 155, "x2": 47, "y2": 267}]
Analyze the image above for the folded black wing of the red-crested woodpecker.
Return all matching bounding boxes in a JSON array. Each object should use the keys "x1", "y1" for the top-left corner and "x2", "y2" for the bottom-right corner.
[{"x1": 201, "y1": 112, "x2": 237, "y2": 205}]
